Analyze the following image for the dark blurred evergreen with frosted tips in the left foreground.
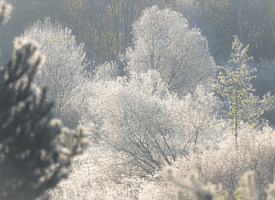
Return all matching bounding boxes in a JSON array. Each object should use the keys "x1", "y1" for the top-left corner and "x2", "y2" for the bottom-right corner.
[{"x1": 0, "y1": 1, "x2": 87, "y2": 200}]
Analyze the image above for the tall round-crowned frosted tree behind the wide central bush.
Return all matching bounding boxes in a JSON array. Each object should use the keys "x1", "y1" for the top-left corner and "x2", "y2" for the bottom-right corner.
[{"x1": 125, "y1": 6, "x2": 215, "y2": 94}]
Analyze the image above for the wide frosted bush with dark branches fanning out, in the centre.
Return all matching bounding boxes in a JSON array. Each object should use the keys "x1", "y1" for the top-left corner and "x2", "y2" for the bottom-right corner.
[{"x1": 84, "y1": 70, "x2": 225, "y2": 173}]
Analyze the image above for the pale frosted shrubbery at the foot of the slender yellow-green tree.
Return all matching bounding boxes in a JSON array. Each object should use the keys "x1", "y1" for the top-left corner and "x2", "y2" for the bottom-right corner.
[{"x1": 171, "y1": 126, "x2": 275, "y2": 199}]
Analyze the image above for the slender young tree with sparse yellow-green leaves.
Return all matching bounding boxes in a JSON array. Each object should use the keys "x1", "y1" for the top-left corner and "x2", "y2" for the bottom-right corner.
[{"x1": 215, "y1": 36, "x2": 267, "y2": 147}]
